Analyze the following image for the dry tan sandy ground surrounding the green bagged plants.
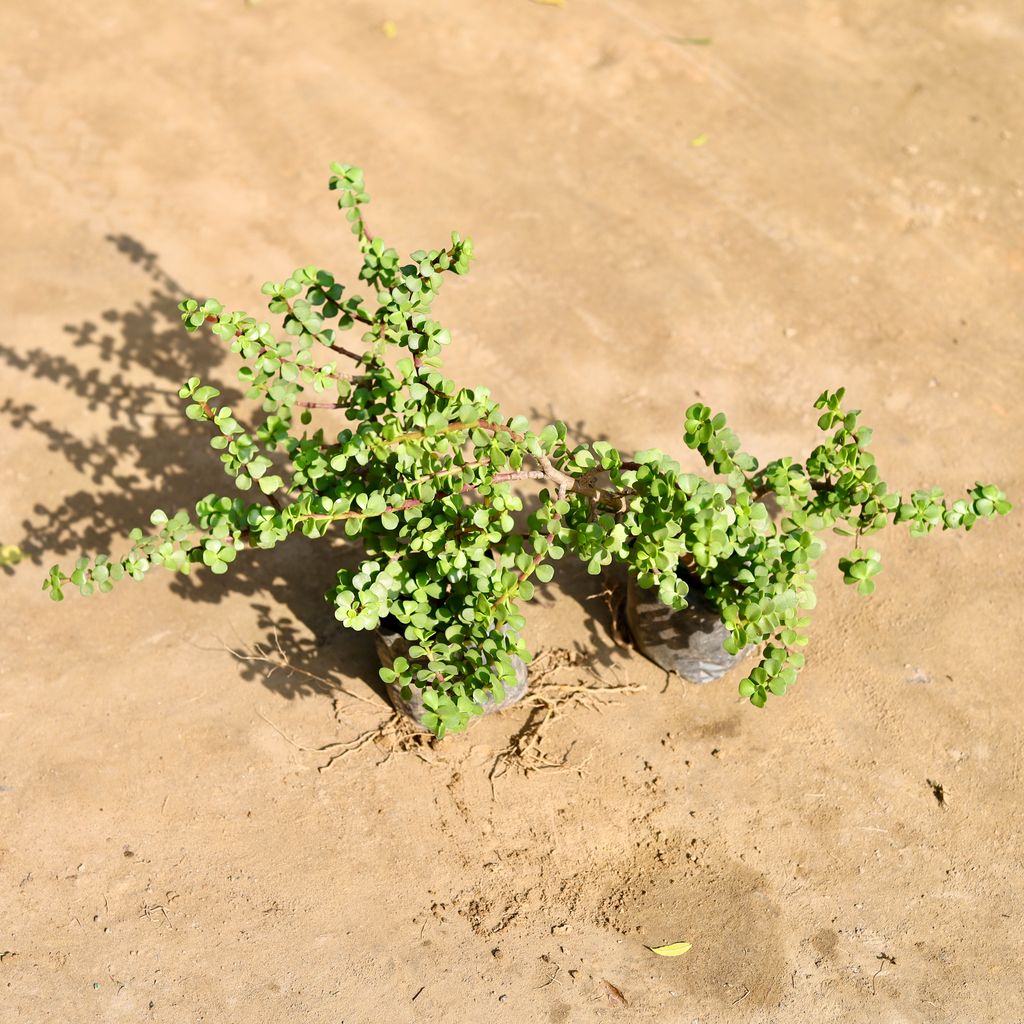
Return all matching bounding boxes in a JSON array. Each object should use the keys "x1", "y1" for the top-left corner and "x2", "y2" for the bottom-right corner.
[{"x1": 0, "y1": 0, "x2": 1024, "y2": 1024}]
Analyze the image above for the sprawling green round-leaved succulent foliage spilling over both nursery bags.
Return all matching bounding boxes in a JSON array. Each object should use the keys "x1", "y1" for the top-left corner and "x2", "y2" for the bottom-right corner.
[{"x1": 44, "y1": 164, "x2": 1010, "y2": 735}]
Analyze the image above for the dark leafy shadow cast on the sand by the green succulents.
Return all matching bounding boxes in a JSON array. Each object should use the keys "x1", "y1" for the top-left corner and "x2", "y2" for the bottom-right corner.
[{"x1": 8, "y1": 234, "x2": 616, "y2": 712}]
